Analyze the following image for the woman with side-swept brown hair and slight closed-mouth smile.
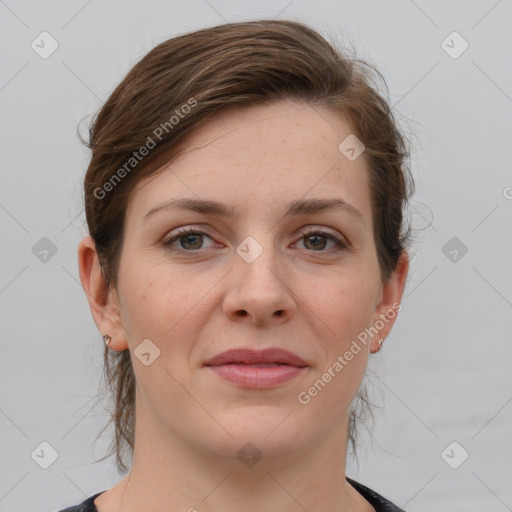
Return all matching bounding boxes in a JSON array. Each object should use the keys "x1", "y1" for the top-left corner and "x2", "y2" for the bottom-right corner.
[{"x1": 61, "y1": 20, "x2": 412, "y2": 512}]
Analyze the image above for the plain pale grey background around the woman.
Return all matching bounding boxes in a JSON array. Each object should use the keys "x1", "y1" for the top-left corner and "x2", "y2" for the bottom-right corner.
[{"x1": 0, "y1": 0, "x2": 512, "y2": 512}]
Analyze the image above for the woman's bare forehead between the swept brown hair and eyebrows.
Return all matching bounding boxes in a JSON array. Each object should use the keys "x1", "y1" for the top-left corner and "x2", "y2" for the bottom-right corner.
[{"x1": 124, "y1": 101, "x2": 371, "y2": 224}]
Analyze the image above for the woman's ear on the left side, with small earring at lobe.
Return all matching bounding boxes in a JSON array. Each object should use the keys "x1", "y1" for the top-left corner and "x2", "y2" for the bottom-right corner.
[{"x1": 78, "y1": 236, "x2": 128, "y2": 351}]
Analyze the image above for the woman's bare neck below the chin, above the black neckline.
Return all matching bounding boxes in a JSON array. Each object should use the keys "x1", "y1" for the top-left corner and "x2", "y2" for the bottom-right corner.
[{"x1": 95, "y1": 400, "x2": 373, "y2": 512}]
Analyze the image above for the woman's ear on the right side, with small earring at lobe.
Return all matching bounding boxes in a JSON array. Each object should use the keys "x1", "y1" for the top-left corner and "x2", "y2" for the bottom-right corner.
[{"x1": 370, "y1": 250, "x2": 409, "y2": 353}]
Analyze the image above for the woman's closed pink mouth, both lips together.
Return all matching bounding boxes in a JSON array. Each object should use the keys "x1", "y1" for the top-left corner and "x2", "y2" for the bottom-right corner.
[{"x1": 204, "y1": 348, "x2": 308, "y2": 389}]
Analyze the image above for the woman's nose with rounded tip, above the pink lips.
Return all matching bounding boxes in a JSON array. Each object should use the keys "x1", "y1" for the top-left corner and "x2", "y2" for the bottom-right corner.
[{"x1": 223, "y1": 245, "x2": 297, "y2": 326}]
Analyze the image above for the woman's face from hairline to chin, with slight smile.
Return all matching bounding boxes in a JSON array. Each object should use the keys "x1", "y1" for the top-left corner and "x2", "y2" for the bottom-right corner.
[{"x1": 91, "y1": 101, "x2": 407, "y2": 464}]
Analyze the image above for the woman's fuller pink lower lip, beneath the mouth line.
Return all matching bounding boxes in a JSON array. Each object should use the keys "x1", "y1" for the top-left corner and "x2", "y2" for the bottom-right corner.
[{"x1": 208, "y1": 364, "x2": 306, "y2": 389}]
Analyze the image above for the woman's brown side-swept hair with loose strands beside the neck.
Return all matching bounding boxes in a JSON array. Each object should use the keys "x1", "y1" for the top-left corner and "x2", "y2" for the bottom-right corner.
[{"x1": 84, "y1": 20, "x2": 413, "y2": 472}]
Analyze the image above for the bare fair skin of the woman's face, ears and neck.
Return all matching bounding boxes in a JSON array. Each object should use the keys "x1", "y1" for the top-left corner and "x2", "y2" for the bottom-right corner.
[{"x1": 79, "y1": 100, "x2": 408, "y2": 512}]
